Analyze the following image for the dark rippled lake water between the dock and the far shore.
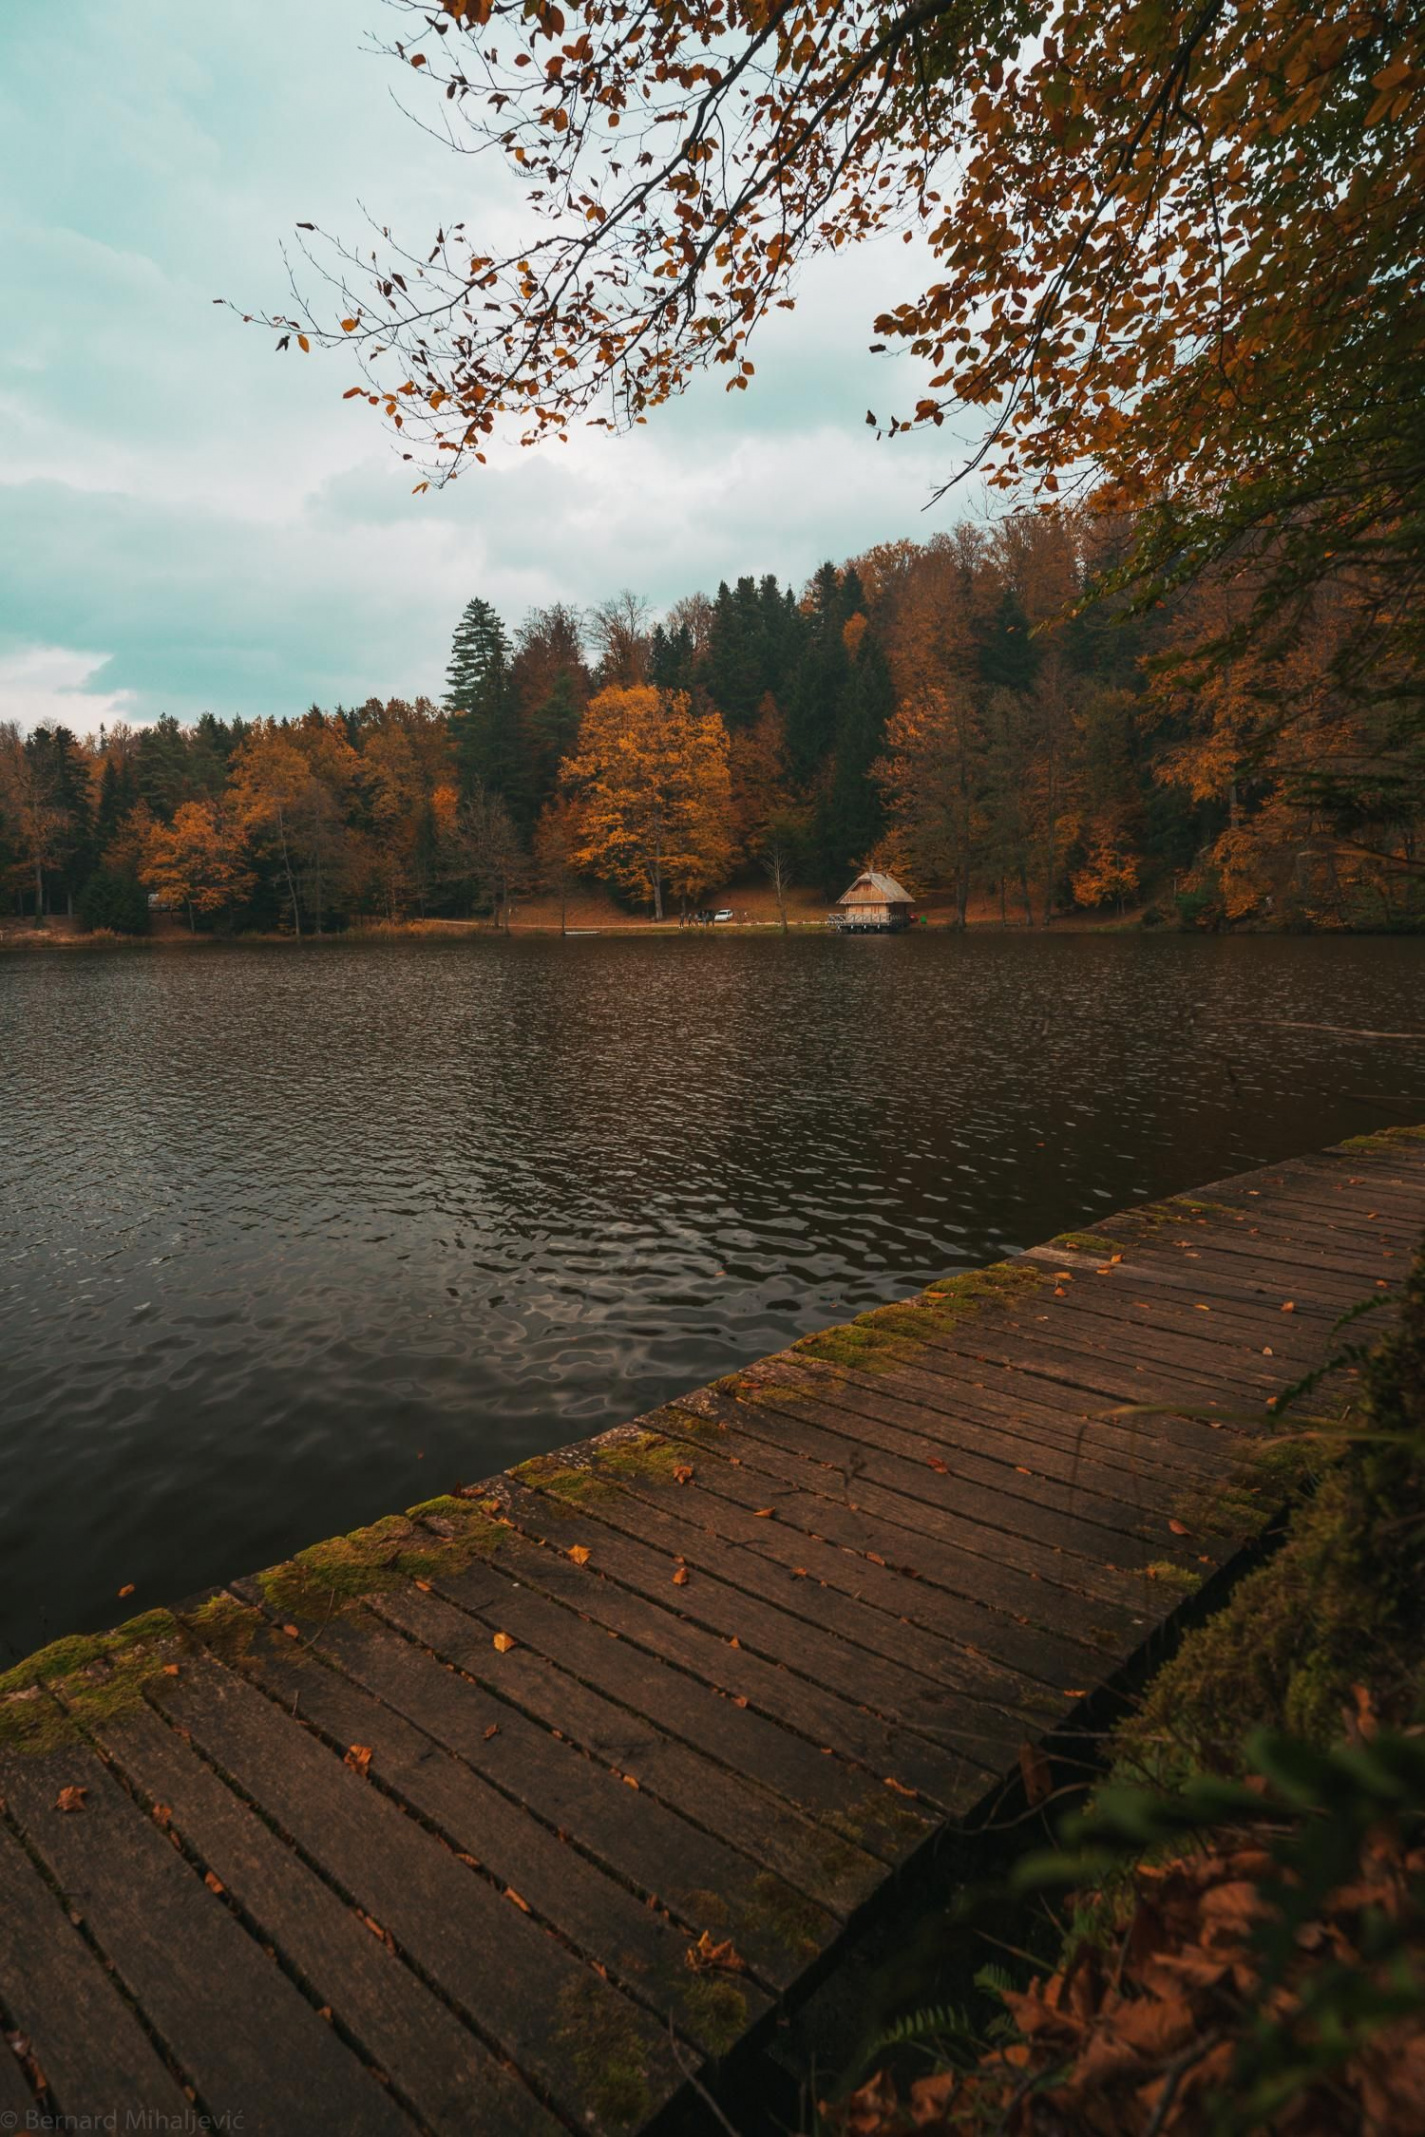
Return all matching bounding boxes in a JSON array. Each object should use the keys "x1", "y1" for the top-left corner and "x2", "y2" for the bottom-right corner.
[{"x1": 0, "y1": 934, "x2": 1425, "y2": 1660}]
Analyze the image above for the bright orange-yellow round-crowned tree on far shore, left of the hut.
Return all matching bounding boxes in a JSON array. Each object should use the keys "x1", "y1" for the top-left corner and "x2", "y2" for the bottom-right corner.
[{"x1": 560, "y1": 684, "x2": 733, "y2": 921}]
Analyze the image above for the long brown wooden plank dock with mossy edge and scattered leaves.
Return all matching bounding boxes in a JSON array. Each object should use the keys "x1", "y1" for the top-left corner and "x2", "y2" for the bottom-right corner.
[{"x1": 0, "y1": 1130, "x2": 1425, "y2": 2137}]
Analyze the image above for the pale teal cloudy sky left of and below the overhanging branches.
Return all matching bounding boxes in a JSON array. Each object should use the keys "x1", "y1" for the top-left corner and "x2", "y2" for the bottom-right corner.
[{"x1": 0, "y1": 0, "x2": 982, "y2": 731}]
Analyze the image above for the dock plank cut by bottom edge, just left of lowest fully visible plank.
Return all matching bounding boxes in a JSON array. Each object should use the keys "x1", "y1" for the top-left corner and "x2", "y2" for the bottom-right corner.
[{"x1": 96, "y1": 1705, "x2": 560, "y2": 2137}]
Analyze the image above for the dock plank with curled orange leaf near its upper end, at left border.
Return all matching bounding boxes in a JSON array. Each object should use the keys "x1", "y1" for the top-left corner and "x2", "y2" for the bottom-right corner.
[{"x1": 0, "y1": 1737, "x2": 412, "y2": 2137}]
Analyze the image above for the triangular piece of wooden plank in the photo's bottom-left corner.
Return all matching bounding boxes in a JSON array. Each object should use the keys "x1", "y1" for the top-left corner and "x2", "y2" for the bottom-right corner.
[{"x1": 0, "y1": 1825, "x2": 190, "y2": 2128}]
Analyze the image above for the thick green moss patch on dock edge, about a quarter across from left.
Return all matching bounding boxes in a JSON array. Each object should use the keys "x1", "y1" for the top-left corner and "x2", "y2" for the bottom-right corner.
[{"x1": 256, "y1": 1498, "x2": 504, "y2": 1620}]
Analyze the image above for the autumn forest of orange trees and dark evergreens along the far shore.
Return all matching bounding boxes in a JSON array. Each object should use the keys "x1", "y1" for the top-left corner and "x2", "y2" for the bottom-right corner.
[{"x1": 0, "y1": 511, "x2": 1425, "y2": 934}]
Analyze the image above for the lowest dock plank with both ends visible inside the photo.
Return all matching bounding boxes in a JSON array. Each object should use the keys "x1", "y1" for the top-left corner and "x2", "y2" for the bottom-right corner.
[{"x1": 156, "y1": 1665, "x2": 684, "y2": 2137}]
